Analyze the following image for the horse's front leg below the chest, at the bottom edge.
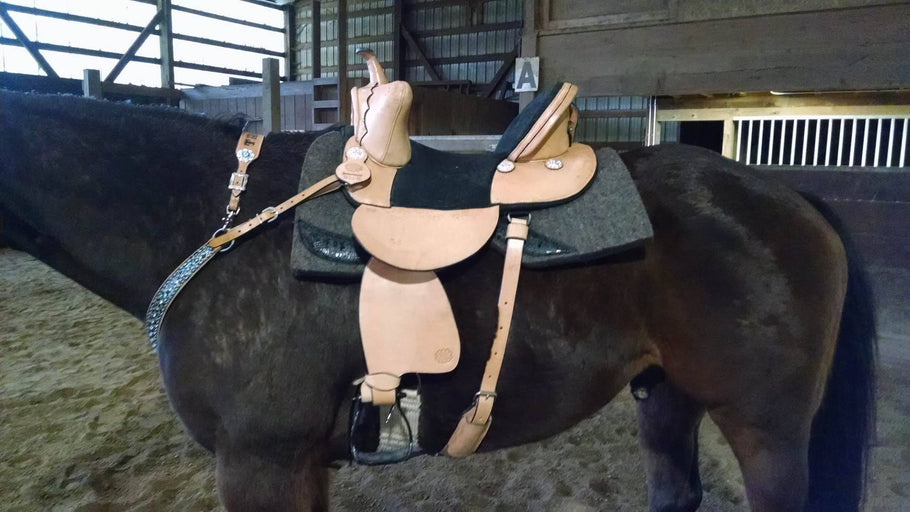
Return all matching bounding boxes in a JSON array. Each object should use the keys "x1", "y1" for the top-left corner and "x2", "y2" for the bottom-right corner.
[{"x1": 215, "y1": 446, "x2": 329, "y2": 512}]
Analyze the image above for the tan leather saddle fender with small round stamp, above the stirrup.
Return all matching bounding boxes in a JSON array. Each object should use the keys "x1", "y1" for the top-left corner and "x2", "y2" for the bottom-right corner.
[{"x1": 360, "y1": 258, "x2": 461, "y2": 403}]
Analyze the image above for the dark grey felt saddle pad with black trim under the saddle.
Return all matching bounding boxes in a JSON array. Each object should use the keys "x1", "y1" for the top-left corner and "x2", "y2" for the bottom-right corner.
[{"x1": 291, "y1": 128, "x2": 652, "y2": 279}]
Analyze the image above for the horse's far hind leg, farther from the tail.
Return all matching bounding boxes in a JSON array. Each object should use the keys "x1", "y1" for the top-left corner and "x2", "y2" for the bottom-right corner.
[{"x1": 638, "y1": 381, "x2": 704, "y2": 512}]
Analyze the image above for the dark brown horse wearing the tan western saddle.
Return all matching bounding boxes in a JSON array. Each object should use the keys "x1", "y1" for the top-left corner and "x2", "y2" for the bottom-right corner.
[{"x1": 0, "y1": 92, "x2": 874, "y2": 511}]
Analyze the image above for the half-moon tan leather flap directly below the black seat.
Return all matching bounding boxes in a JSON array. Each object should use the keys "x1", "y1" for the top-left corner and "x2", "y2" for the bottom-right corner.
[{"x1": 351, "y1": 205, "x2": 499, "y2": 270}]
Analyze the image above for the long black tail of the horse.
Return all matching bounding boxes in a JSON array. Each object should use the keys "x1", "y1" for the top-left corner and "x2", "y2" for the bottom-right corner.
[{"x1": 804, "y1": 195, "x2": 877, "y2": 511}]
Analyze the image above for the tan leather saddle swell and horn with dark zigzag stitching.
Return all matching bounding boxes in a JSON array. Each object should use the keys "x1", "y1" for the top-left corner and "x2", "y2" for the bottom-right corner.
[{"x1": 351, "y1": 52, "x2": 414, "y2": 167}]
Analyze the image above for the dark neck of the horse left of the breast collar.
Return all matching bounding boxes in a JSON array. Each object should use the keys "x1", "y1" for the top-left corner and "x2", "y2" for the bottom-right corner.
[{"x1": 0, "y1": 93, "x2": 290, "y2": 317}]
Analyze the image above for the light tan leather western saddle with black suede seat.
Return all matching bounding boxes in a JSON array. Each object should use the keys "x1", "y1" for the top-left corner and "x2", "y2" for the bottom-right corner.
[{"x1": 335, "y1": 51, "x2": 597, "y2": 456}]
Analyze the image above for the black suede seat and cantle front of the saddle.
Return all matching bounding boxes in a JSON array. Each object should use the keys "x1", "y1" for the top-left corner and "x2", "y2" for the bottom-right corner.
[{"x1": 390, "y1": 82, "x2": 564, "y2": 210}]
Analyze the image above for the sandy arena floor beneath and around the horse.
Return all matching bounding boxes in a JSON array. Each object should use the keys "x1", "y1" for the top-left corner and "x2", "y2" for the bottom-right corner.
[{"x1": 0, "y1": 250, "x2": 910, "y2": 512}]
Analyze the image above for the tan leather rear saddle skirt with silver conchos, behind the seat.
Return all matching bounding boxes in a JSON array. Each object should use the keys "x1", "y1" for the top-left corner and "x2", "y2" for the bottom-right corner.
[{"x1": 490, "y1": 144, "x2": 597, "y2": 205}]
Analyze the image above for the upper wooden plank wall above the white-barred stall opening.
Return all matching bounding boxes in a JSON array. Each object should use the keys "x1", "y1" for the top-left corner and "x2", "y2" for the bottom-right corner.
[{"x1": 523, "y1": 0, "x2": 910, "y2": 96}]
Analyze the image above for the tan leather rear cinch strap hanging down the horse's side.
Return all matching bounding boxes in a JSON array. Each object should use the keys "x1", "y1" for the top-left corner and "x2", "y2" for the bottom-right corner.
[{"x1": 442, "y1": 218, "x2": 528, "y2": 457}]
